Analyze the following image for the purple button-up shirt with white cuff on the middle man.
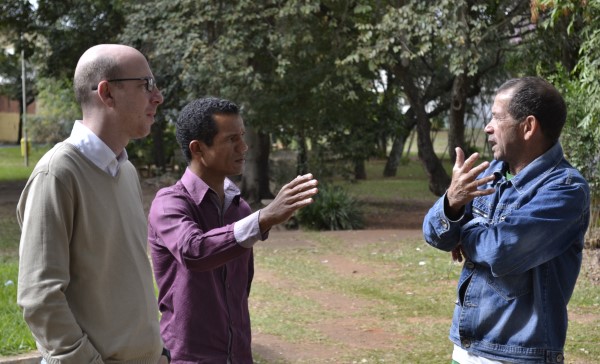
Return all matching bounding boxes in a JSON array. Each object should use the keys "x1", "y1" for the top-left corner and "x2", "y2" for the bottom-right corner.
[{"x1": 148, "y1": 169, "x2": 266, "y2": 364}]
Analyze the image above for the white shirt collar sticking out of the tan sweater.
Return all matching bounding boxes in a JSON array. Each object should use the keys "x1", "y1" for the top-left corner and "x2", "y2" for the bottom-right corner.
[{"x1": 65, "y1": 120, "x2": 128, "y2": 177}]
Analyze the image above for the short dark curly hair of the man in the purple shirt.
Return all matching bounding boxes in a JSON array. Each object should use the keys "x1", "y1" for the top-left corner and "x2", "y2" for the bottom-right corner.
[{"x1": 175, "y1": 97, "x2": 240, "y2": 163}]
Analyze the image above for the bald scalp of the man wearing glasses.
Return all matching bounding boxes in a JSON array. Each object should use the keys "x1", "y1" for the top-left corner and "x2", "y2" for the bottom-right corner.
[{"x1": 73, "y1": 44, "x2": 145, "y2": 107}]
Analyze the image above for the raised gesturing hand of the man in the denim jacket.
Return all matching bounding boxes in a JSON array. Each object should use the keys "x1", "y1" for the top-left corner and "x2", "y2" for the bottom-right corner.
[{"x1": 446, "y1": 147, "x2": 494, "y2": 215}]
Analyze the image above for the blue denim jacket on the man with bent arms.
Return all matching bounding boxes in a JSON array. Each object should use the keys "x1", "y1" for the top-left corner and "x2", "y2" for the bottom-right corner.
[{"x1": 423, "y1": 143, "x2": 590, "y2": 363}]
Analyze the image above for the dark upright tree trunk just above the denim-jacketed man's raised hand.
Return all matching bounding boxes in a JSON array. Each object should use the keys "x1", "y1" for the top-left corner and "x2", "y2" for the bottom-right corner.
[{"x1": 448, "y1": 73, "x2": 468, "y2": 162}]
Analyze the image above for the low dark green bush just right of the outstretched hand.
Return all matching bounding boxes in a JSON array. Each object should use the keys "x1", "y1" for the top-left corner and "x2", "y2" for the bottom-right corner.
[{"x1": 296, "y1": 185, "x2": 364, "y2": 230}]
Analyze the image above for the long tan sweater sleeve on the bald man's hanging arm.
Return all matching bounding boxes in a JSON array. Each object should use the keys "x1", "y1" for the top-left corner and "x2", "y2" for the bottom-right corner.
[{"x1": 17, "y1": 171, "x2": 102, "y2": 364}]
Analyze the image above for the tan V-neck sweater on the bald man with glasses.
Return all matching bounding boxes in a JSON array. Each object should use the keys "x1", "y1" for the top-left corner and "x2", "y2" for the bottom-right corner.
[{"x1": 17, "y1": 143, "x2": 162, "y2": 364}]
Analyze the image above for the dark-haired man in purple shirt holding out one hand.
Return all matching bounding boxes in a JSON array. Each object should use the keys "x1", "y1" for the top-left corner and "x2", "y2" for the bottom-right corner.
[{"x1": 148, "y1": 98, "x2": 317, "y2": 364}]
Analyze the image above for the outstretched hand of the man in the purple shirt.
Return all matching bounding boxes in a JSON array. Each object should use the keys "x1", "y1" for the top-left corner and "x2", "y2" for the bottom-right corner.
[{"x1": 258, "y1": 173, "x2": 318, "y2": 232}]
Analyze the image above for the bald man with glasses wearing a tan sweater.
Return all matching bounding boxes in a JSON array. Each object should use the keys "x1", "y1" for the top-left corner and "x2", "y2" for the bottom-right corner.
[{"x1": 17, "y1": 44, "x2": 169, "y2": 364}]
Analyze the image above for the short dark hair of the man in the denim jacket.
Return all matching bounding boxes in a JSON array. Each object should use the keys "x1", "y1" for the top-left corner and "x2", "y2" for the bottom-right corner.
[{"x1": 496, "y1": 77, "x2": 567, "y2": 144}]
